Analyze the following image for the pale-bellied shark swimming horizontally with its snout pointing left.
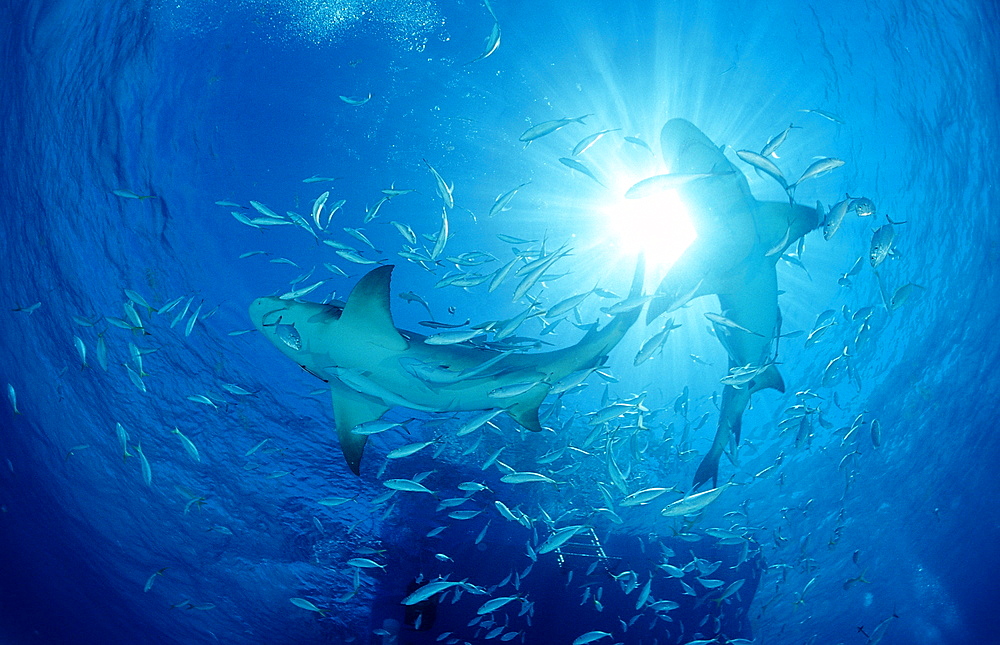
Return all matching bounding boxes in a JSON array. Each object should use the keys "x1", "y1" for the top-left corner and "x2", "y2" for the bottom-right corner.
[{"x1": 250, "y1": 258, "x2": 644, "y2": 475}]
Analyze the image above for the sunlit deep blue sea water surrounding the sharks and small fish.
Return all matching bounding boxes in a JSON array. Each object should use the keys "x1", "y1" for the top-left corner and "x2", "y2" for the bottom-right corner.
[{"x1": 0, "y1": 0, "x2": 1000, "y2": 644}]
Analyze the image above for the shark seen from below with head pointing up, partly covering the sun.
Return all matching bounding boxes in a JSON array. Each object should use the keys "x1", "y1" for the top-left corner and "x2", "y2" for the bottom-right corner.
[{"x1": 646, "y1": 119, "x2": 820, "y2": 490}]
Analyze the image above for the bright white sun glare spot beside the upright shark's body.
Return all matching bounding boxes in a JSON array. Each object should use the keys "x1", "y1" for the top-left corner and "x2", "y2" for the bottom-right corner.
[{"x1": 607, "y1": 191, "x2": 698, "y2": 275}]
